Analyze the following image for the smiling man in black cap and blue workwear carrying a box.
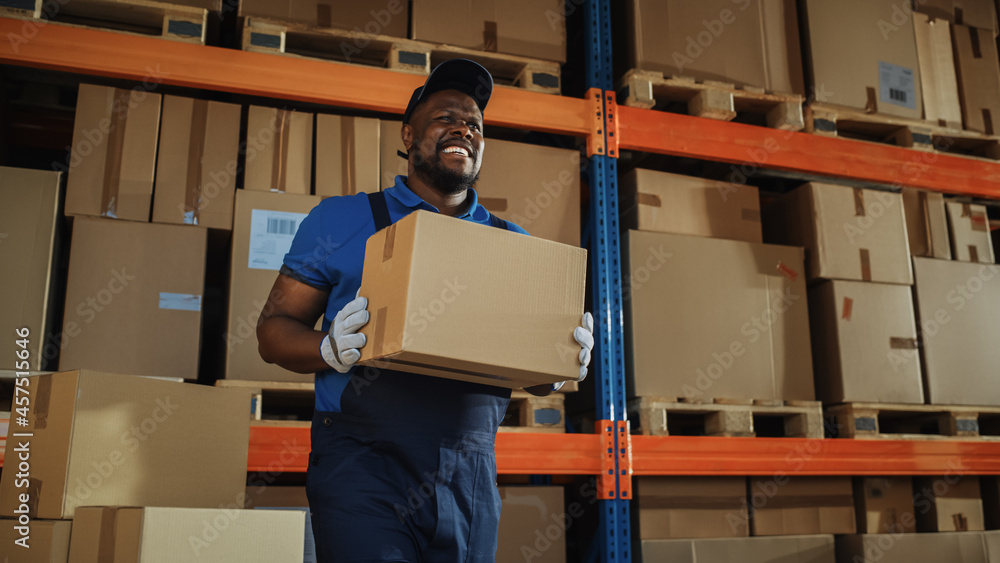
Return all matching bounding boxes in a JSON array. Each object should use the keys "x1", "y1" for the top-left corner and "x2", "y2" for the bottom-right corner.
[{"x1": 257, "y1": 59, "x2": 594, "y2": 562}]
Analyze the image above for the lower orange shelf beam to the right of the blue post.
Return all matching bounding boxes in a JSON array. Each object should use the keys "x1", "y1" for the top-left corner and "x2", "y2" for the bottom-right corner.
[{"x1": 632, "y1": 436, "x2": 1000, "y2": 476}]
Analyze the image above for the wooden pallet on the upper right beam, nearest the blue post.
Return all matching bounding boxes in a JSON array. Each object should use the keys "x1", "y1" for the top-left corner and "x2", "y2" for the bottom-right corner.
[{"x1": 618, "y1": 70, "x2": 805, "y2": 131}]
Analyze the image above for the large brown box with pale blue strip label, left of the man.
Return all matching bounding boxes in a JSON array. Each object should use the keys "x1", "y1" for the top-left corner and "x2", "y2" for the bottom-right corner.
[{"x1": 59, "y1": 217, "x2": 207, "y2": 379}]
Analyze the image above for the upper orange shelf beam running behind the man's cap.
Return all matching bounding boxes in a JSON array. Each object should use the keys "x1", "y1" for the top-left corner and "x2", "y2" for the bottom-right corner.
[{"x1": 0, "y1": 18, "x2": 591, "y2": 137}]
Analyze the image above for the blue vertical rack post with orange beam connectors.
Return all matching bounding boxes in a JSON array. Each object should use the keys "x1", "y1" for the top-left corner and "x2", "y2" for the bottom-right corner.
[{"x1": 584, "y1": 0, "x2": 631, "y2": 563}]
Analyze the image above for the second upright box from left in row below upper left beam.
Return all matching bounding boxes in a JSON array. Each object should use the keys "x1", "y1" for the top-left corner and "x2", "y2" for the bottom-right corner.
[{"x1": 153, "y1": 96, "x2": 240, "y2": 231}]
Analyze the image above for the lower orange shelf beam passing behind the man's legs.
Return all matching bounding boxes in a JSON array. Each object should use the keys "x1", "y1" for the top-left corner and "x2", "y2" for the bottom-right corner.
[{"x1": 247, "y1": 425, "x2": 601, "y2": 475}]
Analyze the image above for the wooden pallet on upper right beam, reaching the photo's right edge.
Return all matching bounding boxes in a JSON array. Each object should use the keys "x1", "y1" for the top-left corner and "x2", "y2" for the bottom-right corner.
[{"x1": 805, "y1": 103, "x2": 1000, "y2": 160}]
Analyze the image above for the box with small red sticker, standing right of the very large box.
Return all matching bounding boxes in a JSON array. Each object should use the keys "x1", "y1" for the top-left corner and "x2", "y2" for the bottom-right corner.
[{"x1": 809, "y1": 281, "x2": 924, "y2": 403}]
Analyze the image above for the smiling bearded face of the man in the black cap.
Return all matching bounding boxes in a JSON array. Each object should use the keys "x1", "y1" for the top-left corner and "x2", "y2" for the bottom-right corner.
[{"x1": 403, "y1": 90, "x2": 484, "y2": 195}]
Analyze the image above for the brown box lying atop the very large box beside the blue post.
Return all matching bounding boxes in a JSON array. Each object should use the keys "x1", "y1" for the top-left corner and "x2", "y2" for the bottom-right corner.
[{"x1": 620, "y1": 168, "x2": 761, "y2": 242}]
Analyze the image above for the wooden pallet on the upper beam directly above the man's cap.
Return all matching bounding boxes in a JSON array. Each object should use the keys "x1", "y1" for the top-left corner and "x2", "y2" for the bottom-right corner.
[{"x1": 241, "y1": 17, "x2": 560, "y2": 94}]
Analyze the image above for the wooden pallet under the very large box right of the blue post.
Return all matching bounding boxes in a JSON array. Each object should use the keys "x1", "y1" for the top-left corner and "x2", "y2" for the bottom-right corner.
[{"x1": 628, "y1": 397, "x2": 823, "y2": 438}]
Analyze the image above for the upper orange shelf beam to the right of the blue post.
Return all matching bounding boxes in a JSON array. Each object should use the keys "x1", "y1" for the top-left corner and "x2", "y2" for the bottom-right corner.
[{"x1": 618, "y1": 106, "x2": 1000, "y2": 199}]
